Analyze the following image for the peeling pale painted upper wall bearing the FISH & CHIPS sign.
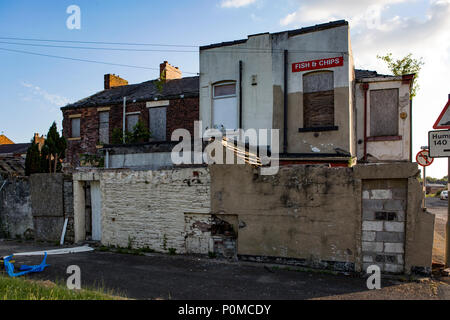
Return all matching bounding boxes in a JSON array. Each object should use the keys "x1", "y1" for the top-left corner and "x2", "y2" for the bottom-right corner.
[{"x1": 200, "y1": 25, "x2": 355, "y2": 155}]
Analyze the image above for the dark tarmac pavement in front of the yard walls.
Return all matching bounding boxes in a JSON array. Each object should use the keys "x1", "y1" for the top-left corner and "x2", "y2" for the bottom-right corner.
[{"x1": 0, "y1": 240, "x2": 450, "y2": 300}]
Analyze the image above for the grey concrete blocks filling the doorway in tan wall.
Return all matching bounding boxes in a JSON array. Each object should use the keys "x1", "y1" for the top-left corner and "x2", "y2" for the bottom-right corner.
[{"x1": 362, "y1": 184, "x2": 407, "y2": 273}]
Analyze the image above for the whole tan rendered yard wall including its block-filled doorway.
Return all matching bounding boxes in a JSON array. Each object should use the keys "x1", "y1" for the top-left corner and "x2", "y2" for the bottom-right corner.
[{"x1": 210, "y1": 163, "x2": 434, "y2": 274}]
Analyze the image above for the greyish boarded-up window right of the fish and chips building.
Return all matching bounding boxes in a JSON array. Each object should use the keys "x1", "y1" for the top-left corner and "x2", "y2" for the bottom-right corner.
[{"x1": 370, "y1": 89, "x2": 398, "y2": 137}]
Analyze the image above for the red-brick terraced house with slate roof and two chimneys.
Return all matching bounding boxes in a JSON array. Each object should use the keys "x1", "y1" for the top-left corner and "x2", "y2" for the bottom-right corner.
[{"x1": 61, "y1": 61, "x2": 199, "y2": 169}]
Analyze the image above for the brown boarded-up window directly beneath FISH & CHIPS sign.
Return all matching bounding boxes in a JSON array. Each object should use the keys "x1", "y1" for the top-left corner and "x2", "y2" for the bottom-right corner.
[{"x1": 303, "y1": 71, "x2": 334, "y2": 128}]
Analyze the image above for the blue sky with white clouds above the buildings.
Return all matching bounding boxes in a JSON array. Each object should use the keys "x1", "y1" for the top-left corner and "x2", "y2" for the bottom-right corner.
[{"x1": 0, "y1": 0, "x2": 450, "y2": 177}]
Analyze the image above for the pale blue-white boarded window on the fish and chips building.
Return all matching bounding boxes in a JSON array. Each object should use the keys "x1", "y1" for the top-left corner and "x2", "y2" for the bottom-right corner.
[{"x1": 213, "y1": 83, "x2": 238, "y2": 130}]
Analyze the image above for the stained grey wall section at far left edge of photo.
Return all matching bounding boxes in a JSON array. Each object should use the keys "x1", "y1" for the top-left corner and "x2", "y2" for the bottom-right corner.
[{"x1": 0, "y1": 176, "x2": 33, "y2": 238}]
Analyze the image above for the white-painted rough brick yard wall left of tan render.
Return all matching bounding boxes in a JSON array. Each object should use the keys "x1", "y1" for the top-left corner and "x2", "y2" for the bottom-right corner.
[{"x1": 99, "y1": 167, "x2": 210, "y2": 253}]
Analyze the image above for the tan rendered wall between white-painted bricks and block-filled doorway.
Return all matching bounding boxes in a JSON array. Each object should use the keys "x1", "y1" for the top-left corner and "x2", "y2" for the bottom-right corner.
[{"x1": 211, "y1": 165, "x2": 361, "y2": 270}]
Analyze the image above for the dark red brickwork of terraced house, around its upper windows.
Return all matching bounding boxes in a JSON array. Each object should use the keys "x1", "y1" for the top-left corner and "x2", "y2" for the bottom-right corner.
[{"x1": 63, "y1": 98, "x2": 199, "y2": 168}]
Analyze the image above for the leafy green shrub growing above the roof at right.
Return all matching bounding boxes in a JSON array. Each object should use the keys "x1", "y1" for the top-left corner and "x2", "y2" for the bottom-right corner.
[{"x1": 377, "y1": 53, "x2": 425, "y2": 100}]
